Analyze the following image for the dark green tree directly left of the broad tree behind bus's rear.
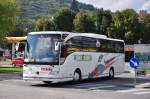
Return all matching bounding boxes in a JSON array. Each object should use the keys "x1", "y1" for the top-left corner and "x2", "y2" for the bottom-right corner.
[{"x1": 92, "y1": 9, "x2": 112, "y2": 35}]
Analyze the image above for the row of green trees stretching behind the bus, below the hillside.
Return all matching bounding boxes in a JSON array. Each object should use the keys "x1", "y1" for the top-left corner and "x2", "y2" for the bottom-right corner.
[{"x1": 19, "y1": 4, "x2": 150, "y2": 44}]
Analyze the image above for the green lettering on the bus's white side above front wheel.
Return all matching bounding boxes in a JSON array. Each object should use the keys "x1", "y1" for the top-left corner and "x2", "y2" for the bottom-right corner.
[{"x1": 74, "y1": 55, "x2": 92, "y2": 61}]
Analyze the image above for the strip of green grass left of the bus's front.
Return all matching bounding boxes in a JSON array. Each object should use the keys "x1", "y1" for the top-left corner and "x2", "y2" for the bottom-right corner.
[{"x1": 0, "y1": 67, "x2": 23, "y2": 73}]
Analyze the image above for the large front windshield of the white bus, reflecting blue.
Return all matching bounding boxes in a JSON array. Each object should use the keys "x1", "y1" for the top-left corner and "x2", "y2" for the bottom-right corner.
[{"x1": 24, "y1": 34, "x2": 61, "y2": 64}]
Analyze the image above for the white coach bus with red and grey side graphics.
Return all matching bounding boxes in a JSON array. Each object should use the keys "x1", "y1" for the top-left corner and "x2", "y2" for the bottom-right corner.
[{"x1": 23, "y1": 31, "x2": 125, "y2": 83}]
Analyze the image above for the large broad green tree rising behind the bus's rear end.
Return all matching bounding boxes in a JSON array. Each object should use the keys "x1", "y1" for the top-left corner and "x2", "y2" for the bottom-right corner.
[{"x1": 113, "y1": 9, "x2": 140, "y2": 44}]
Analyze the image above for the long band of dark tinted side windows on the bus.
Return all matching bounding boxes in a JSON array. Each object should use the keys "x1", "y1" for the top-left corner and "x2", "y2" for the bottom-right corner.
[{"x1": 63, "y1": 36, "x2": 124, "y2": 53}]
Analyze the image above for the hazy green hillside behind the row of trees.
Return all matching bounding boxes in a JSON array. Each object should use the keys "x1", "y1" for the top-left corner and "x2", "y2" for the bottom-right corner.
[{"x1": 20, "y1": 0, "x2": 95, "y2": 19}]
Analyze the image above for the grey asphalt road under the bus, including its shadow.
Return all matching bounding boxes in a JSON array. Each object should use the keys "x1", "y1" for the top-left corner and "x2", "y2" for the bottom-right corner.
[{"x1": 0, "y1": 74, "x2": 150, "y2": 99}]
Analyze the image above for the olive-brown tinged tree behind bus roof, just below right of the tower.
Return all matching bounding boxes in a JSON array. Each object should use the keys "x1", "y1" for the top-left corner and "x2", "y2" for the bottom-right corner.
[{"x1": 74, "y1": 13, "x2": 95, "y2": 33}]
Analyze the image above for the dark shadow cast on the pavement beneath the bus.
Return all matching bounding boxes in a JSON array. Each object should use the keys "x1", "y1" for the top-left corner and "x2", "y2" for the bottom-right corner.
[{"x1": 31, "y1": 77, "x2": 150, "y2": 91}]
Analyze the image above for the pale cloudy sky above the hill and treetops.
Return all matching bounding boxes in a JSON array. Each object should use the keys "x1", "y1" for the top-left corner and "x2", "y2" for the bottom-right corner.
[{"x1": 77, "y1": 0, "x2": 150, "y2": 13}]
